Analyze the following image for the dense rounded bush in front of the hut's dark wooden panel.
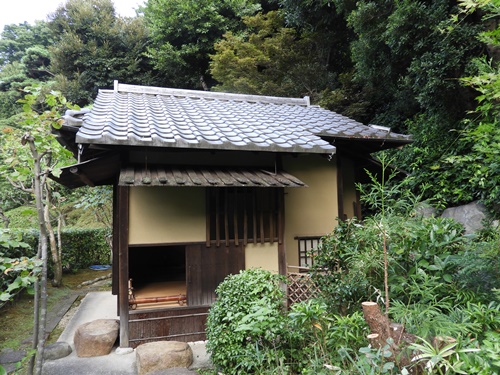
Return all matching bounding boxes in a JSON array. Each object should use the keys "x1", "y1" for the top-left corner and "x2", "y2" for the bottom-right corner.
[{"x1": 206, "y1": 269, "x2": 285, "y2": 374}]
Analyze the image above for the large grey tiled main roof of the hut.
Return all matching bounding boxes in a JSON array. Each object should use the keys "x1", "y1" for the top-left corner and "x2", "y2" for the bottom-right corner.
[{"x1": 76, "y1": 83, "x2": 408, "y2": 153}]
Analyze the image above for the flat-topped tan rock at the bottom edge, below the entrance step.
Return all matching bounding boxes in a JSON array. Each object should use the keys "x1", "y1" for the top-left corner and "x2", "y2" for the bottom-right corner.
[{"x1": 136, "y1": 341, "x2": 193, "y2": 375}]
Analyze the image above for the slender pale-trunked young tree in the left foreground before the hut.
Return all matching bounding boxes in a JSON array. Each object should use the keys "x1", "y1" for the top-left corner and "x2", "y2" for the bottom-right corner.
[{"x1": 1, "y1": 87, "x2": 77, "y2": 374}]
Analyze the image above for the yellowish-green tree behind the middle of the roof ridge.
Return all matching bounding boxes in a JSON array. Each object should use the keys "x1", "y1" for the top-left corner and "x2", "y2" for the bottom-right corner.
[{"x1": 210, "y1": 11, "x2": 333, "y2": 96}]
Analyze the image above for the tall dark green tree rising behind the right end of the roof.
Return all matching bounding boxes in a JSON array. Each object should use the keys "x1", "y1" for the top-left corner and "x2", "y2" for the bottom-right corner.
[{"x1": 326, "y1": 0, "x2": 486, "y2": 213}]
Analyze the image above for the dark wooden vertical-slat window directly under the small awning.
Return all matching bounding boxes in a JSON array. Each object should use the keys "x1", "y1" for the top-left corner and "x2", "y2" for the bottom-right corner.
[{"x1": 207, "y1": 188, "x2": 283, "y2": 246}]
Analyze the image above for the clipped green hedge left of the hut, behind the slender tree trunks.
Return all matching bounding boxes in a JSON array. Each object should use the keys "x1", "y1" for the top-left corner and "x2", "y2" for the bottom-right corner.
[{"x1": 0, "y1": 228, "x2": 111, "y2": 272}]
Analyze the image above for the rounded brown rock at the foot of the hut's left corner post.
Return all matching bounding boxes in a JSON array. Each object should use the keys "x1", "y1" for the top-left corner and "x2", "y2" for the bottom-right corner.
[{"x1": 74, "y1": 319, "x2": 119, "y2": 357}]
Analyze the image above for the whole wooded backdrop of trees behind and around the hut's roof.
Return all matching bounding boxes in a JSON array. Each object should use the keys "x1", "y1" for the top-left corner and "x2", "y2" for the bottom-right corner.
[{"x1": 0, "y1": 0, "x2": 500, "y2": 223}]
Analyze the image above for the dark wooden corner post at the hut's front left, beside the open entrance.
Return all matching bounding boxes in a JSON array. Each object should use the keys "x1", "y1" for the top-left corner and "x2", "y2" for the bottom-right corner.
[{"x1": 117, "y1": 186, "x2": 130, "y2": 348}]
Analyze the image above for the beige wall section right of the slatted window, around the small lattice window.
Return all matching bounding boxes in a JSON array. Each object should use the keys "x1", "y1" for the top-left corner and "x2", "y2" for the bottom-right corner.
[{"x1": 283, "y1": 155, "x2": 338, "y2": 266}]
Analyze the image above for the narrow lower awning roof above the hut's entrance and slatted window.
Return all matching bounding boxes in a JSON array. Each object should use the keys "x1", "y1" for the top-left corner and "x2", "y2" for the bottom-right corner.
[{"x1": 118, "y1": 166, "x2": 306, "y2": 187}]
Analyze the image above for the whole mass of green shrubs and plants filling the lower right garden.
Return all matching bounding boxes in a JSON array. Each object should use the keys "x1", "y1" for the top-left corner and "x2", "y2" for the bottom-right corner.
[{"x1": 207, "y1": 166, "x2": 500, "y2": 375}]
